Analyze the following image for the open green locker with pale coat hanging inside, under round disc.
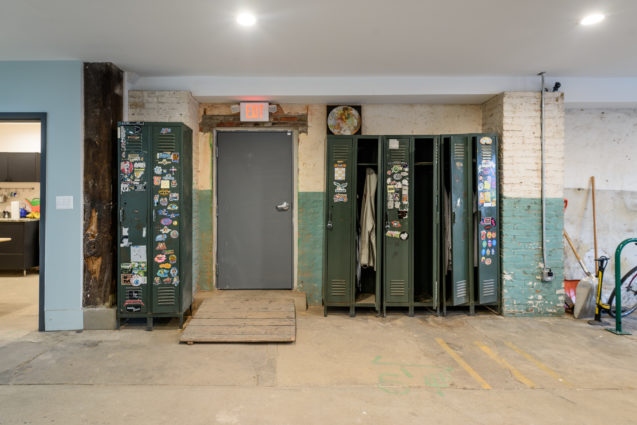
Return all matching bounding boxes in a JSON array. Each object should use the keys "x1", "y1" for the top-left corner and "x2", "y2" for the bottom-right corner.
[{"x1": 323, "y1": 136, "x2": 382, "y2": 316}]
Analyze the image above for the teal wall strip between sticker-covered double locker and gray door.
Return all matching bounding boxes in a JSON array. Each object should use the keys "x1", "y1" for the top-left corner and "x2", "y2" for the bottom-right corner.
[{"x1": 193, "y1": 190, "x2": 213, "y2": 291}]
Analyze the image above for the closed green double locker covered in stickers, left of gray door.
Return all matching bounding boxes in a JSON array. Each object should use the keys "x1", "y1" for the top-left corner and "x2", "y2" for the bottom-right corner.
[{"x1": 117, "y1": 122, "x2": 193, "y2": 329}]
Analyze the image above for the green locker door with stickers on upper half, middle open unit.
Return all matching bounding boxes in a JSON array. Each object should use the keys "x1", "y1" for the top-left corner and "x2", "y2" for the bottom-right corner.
[{"x1": 379, "y1": 137, "x2": 413, "y2": 305}]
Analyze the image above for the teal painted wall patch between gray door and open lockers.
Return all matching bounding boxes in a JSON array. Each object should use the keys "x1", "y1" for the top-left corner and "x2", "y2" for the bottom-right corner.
[{"x1": 297, "y1": 192, "x2": 325, "y2": 305}]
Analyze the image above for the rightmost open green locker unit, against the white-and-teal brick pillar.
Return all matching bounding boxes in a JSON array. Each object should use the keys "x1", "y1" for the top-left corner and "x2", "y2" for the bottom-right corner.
[{"x1": 441, "y1": 134, "x2": 500, "y2": 314}]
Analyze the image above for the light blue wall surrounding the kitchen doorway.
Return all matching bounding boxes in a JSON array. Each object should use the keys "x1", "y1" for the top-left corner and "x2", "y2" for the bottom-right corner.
[{"x1": 0, "y1": 61, "x2": 83, "y2": 330}]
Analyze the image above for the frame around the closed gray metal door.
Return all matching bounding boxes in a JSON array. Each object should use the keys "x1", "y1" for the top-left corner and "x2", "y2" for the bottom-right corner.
[{"x1": 211, "y1": 127, "x2": 299, "y2": 290}]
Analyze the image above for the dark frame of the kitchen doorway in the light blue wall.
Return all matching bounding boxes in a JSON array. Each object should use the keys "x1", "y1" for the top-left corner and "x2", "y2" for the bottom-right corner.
[{"x1": 0, "y1": 112, "x2": 47, "y2": 332}]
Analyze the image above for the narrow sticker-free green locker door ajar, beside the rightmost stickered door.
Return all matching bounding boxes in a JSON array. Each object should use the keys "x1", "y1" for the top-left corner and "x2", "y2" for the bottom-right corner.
[{"x1": 449, "y1": 136, "x2": 473, "y2": 306}]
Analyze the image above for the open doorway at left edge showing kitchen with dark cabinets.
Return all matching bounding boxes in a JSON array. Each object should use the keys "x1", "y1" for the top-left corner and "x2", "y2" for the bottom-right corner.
[{"x1": 0, "y1": 113, "x2": 47, "y2": 332}]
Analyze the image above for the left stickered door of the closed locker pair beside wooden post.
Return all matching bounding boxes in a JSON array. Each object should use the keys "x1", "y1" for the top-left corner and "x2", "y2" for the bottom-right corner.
[{"x1": 117, "y1": 124, "x2": 151, "y2": 315}]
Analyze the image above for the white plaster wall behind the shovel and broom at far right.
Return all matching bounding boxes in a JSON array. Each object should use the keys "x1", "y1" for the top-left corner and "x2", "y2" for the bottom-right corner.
[{"x1": 564, "y1": 108, "x2": 637, "y2": 292}]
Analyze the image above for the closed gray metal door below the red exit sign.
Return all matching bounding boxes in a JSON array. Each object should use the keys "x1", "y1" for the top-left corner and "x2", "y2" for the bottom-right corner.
[{"x1": 217, "y1": 132, "x2": 294, "y2": 289}]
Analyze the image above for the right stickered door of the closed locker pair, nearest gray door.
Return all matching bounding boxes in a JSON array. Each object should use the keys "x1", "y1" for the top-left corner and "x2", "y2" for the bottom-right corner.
[{"x1": 149, "y1": 124, "x2": 180, "y2": 313}]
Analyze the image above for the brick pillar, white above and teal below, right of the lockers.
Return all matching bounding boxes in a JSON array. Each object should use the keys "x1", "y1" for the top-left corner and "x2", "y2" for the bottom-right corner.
[{"x1": 482, "y1": 92, "x2": 564, "y2": 315}]
